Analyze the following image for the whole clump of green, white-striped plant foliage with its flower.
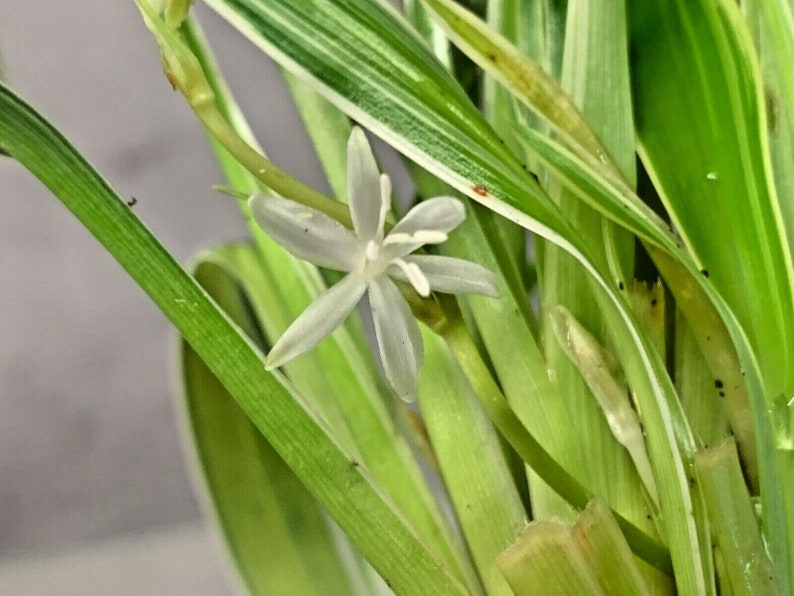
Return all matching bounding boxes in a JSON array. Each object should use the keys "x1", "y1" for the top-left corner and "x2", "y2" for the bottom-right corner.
[{"x1": 0, "y1": 0, "x2": 794, "y2": 594}]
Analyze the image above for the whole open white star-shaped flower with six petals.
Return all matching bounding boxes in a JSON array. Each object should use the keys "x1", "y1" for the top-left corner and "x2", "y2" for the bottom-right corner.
[{"x1": 249, "y1": 127, "x2": 499, "y2": 401}]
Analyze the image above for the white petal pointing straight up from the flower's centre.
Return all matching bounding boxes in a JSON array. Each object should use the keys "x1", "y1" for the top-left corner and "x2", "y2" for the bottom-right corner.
[{"x1": 347, "y1": 126, "x2": 391, "y2": 242}]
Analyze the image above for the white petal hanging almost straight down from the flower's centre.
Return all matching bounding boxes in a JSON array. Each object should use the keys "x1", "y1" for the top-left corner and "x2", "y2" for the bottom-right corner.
[{"x1": 367, "y1": 276, "x2": 424, "y2": 401}]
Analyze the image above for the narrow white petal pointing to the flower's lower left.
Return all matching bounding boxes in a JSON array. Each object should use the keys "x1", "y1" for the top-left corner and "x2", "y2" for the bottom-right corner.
[{"x1": 265, "y1": 273, "x2": 367, "y2": 369}]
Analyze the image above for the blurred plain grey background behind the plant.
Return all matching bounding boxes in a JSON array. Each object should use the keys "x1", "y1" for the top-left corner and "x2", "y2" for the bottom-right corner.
[{"x1": 0, "y1": 0, "x2": 352, "y2": 594}]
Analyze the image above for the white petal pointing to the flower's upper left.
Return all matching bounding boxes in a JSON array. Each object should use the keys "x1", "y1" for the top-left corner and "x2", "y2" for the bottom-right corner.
[{"x1": 248, "y1": 194, "x2": 361, "y2": 271}]
